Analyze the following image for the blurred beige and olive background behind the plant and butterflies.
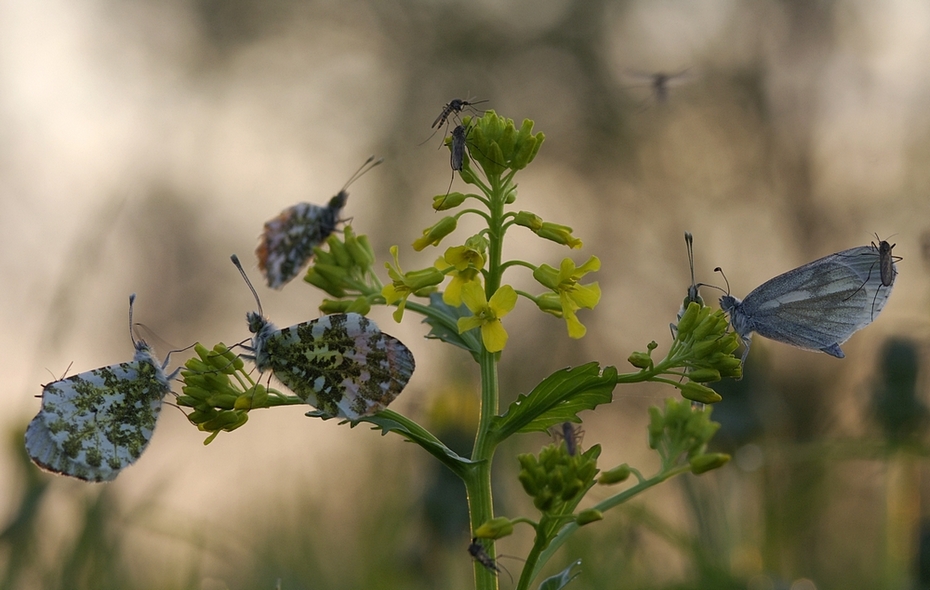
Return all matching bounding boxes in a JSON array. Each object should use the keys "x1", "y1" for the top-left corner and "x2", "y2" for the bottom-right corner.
[{"x1": 0, "y1": 0, "x2": 930, "y2": 590}]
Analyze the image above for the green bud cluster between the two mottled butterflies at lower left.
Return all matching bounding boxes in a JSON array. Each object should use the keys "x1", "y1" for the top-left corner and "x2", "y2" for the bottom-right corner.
[{"x1": 177, "y1": 343, "x2": 268, "y2": 444}]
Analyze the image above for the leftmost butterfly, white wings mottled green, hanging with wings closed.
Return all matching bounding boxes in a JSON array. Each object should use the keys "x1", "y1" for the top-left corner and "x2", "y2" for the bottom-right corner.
[{"x1": 26, "y1": 295, "x2": 177, "y2": 482}]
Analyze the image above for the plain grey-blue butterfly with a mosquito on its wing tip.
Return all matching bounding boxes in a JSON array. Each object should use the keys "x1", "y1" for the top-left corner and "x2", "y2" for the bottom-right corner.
[{"x1": 720, "y1": 245, "x2": 897, "y2": 362}]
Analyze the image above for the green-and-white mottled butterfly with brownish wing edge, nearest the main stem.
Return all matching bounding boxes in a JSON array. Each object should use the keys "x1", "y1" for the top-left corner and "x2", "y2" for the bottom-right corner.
[{"x1": 232, "y1": 255, "x2": 415, "y2": 421}]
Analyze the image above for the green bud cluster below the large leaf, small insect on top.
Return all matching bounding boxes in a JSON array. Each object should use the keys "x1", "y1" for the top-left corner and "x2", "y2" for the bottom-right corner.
[{"x1": 517, "y1": 442, "x2": 601, "y2": 514}]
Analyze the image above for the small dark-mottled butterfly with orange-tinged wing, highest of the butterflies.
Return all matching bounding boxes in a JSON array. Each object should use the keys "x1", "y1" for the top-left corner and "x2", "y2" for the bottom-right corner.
[{"x1": 255, "y1": 156, "x2": 384, "y2": 289}]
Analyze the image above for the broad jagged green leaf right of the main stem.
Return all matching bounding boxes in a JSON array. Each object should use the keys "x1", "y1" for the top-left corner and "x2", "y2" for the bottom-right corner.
[{"x1": 491, "y1": 362, "x2": 617, "y2": 440}]
